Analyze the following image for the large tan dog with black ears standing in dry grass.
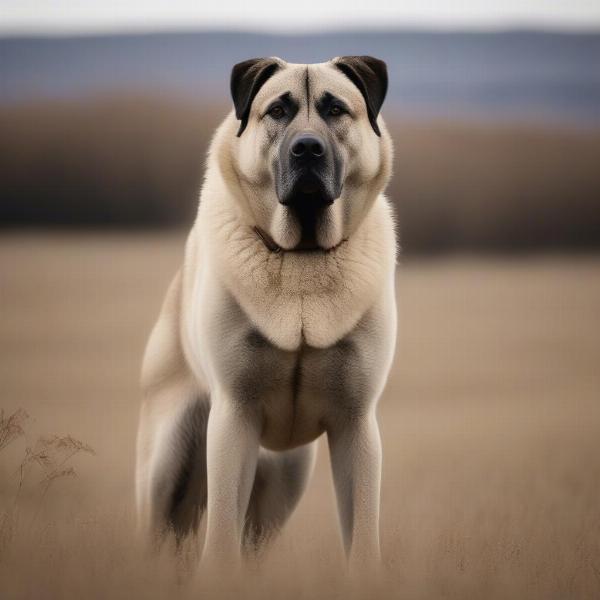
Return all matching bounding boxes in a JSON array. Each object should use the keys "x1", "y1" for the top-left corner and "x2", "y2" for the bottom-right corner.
[{"x1": 136, "y1": 56, "x2": 396, "y2": 563}]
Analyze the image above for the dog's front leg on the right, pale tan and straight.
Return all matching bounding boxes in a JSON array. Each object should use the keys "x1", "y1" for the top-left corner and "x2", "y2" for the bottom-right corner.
[{"x1": 327, "y1": 410, "x2": 381, "y2": 569}]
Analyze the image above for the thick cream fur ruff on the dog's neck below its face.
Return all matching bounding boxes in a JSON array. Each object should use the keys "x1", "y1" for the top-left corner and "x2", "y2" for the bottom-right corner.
[{"x1": 202, "y1": 192, "x2": 395, "y2": 350}]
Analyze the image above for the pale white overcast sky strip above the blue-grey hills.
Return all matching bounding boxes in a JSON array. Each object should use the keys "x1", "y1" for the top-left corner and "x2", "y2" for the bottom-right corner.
[{"x1": 0, "y1": 0, "x2": 600, "y2": 33}]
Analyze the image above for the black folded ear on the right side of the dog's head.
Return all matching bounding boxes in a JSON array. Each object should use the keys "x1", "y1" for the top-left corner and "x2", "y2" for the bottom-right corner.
[{"x1": 334, "y1": 56, "x2": 387, "y2": 136}]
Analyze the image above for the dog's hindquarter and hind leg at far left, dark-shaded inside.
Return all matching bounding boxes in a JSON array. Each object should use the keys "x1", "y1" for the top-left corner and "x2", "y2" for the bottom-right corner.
[{"x1": 136, "y1": 275, "x2": 210, "y2": 541}]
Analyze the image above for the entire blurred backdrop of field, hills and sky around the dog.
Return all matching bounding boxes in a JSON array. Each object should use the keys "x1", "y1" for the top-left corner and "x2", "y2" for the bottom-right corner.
[{"x1": 0, "y1": 0, "x2": 600, "y2": 600}]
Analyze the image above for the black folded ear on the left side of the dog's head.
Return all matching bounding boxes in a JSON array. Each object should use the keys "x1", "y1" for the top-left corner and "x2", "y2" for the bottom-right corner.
[{"x1": 231, "y1": 58, "x2": 279, "y2": 137}]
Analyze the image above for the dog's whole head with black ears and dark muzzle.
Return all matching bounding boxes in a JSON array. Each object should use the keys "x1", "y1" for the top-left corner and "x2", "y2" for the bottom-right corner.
[{"x1": 230, "y1": 57, "x2": 391, "y2": 250}]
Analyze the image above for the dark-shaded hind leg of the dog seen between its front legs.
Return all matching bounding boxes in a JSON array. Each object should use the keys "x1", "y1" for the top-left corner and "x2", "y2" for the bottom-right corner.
[{"x1": 244, "y1": 442, "x2": 317, "y2": 552}]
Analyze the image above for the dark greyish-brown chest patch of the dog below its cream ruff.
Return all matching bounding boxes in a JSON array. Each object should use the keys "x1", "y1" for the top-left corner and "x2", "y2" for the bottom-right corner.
[{"x1": 204, "y1": 292, "x2": 373, "y2": 450}]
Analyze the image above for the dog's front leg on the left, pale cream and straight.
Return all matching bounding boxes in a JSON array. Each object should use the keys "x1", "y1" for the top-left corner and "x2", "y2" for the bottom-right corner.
[{"x1": 203, "y1": 395, "x2": 260, "y2": 568}]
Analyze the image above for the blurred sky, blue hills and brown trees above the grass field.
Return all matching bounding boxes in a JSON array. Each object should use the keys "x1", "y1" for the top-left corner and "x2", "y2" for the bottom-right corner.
[{"x1": 0, "y1": 0, "x2": 600, "y2": 248}]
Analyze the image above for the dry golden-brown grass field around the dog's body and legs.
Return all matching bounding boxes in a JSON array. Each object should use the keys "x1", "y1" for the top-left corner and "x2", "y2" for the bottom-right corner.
[{"x1": 0, "y1": 233, "x2": 600, "y2": 600}]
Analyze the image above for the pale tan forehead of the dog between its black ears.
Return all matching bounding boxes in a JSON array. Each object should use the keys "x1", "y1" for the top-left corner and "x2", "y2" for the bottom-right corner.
[{"x1": 255, "y1": 61, "x2": 364, "y2": 107}]
